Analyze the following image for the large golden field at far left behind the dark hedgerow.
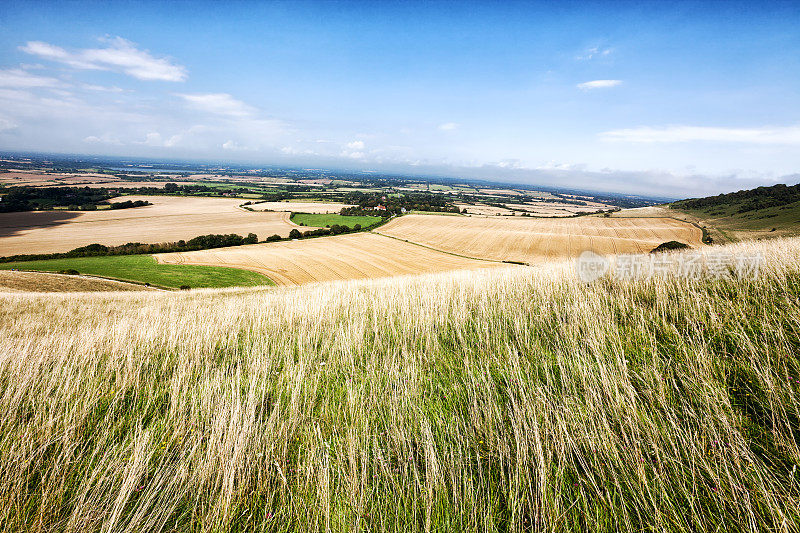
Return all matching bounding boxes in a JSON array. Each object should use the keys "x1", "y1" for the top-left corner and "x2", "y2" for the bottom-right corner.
[{"x1": 0, "y1": 196, "x2": 308, "y2": 256}]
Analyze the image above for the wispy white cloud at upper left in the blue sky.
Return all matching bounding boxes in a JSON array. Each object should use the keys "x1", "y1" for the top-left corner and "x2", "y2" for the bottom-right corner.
[{"x1": 20, "y1": 37, "x2": 186, "y2": 81}]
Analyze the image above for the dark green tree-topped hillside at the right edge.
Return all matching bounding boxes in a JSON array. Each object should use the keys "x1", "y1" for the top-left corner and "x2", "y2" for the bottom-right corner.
[{"x1": 670, "y1": 185, "x2": 800, "y2": 242}]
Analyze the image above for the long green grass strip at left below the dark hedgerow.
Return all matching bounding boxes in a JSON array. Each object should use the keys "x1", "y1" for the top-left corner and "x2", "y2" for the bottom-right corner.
[{"x1": 0, "y1": 255, "x2": 271, "y2": 289}]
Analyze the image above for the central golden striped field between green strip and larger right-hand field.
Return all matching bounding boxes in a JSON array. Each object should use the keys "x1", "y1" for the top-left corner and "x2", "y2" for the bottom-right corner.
[{"x1": 155, "y1": 231, "x2": 499, "y2": 285}]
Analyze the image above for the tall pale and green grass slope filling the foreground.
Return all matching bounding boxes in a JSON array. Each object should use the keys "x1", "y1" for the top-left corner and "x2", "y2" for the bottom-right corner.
[{"x1": 0, "y1": 239, "x2": 800, "y2": 533}]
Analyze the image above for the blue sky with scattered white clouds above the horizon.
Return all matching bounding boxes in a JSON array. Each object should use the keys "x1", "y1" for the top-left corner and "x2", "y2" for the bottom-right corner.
[{"x1": 0, "y1": 0, "x2": 800, "y2": 197}]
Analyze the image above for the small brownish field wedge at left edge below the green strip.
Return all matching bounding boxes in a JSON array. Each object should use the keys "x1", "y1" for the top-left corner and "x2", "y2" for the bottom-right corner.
[{"x1": 0, "y1": 270, "x2": 155, "y2": 292}]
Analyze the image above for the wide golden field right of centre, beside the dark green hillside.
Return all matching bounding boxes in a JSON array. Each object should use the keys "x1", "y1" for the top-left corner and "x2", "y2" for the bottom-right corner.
[{"x1": 376, "y1": 215, "x2": 702, "y2": 263}]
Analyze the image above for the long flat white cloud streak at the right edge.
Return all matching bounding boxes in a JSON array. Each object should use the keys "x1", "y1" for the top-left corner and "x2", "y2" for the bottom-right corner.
[{"x1": 600, "y1": 122, "x2": 800, "y2": 145}]
